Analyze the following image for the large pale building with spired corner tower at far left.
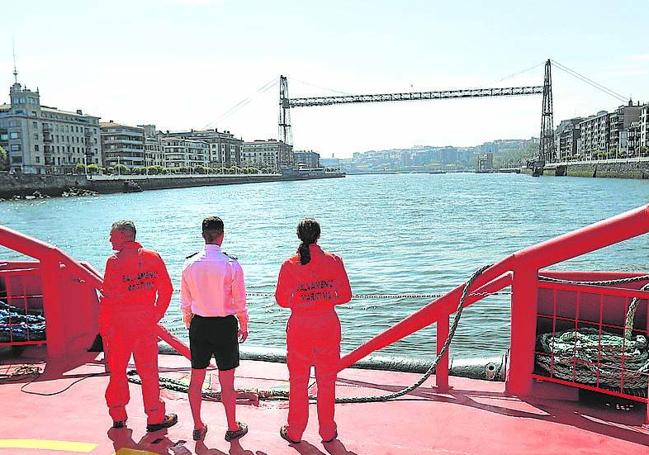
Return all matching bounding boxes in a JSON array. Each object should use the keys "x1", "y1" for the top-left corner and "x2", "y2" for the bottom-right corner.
[{"x1": 0, "y1": 79, "x2": 102, "y2": 174}]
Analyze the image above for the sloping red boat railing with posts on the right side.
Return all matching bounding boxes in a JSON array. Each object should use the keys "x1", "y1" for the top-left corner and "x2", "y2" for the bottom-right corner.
[{"x1": 340, "y1": 205, "x2": 649, "y2": 422}]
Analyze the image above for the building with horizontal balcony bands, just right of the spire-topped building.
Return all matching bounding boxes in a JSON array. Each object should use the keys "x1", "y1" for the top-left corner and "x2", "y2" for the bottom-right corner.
[{"x1": 100, "y1": 120, "x2": 146, "y2": 169}]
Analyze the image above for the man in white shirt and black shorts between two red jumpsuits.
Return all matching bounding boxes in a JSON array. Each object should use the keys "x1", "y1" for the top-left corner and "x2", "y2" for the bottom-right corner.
[{"x1": 180, "y1": 216, "x2": 248, "y2": 441}]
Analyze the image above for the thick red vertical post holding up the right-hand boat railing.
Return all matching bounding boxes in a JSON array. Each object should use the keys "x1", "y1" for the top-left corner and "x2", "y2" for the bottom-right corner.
[{"x1": 505, "y1": 261, "x2": 538, "y2": 396}]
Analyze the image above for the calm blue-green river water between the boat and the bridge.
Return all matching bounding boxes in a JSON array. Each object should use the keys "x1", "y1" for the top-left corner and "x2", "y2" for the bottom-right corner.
[{"x1": 0, "y1": 174, "x2": 649, "y2": 357}]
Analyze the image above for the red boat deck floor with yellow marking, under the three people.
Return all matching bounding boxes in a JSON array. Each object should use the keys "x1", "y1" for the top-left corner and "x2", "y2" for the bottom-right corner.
[{"x1": 0, "y1": 347, "x2": 649, "y2": 455}]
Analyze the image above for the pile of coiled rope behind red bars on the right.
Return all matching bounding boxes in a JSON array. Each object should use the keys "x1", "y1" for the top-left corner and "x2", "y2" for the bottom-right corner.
[{"x1": 536, "y1": 275, "x2": 649, "y2": 391}]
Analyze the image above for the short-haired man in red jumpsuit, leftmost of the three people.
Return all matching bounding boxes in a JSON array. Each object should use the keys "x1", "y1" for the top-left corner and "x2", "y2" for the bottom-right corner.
[{"x1": 99, "y1": 221, "x2": 178, "y2": 432}]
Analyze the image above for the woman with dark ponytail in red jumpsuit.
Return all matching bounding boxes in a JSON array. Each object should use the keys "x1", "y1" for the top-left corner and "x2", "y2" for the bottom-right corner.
[{"x1": 275, "y1": 219, "x2": 352, "y2": 443}]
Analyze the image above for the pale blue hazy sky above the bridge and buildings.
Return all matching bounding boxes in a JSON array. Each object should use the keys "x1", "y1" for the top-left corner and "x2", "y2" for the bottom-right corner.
[{"x1": 0, "y1": 0, "x2": 649, "y2": 157}]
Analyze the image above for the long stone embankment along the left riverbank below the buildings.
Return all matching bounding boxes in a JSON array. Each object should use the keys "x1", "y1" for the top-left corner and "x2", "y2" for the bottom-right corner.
[{"x1": 0, "y1": 173, "x2": 345, "y2": 199}]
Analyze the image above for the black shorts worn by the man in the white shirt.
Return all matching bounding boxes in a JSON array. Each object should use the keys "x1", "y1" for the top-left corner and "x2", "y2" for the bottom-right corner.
[{"x1": 189, "y1": 315, "x2": 239, "y2": 371}]
